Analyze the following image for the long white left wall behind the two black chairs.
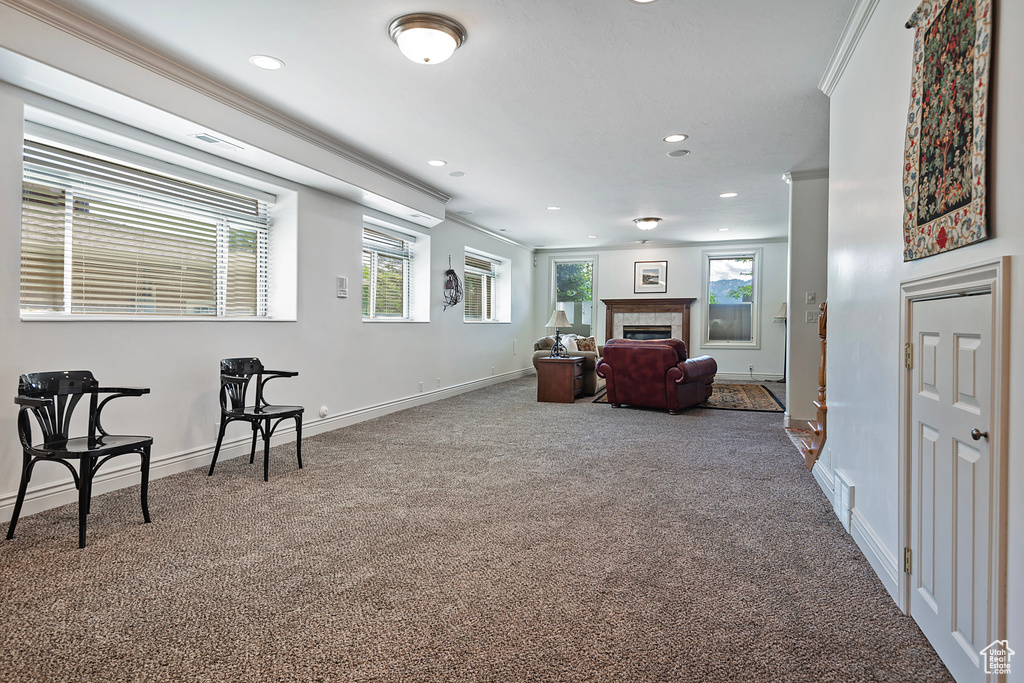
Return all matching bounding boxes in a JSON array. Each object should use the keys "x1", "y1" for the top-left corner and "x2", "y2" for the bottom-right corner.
[{"x1": 0, "y1": 75, "x2": 535, "y2": 520}]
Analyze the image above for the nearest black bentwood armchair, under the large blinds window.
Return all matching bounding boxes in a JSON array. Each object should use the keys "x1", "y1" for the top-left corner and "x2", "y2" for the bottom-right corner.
[{"x1": 7, "y1": 370, "x2": 153, "y2": 548}]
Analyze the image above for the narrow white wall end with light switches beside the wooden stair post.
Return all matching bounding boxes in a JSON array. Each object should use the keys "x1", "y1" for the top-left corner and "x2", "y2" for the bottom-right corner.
[{"x1": 785, "y1": 171, "x2": 828, "y2": 429}]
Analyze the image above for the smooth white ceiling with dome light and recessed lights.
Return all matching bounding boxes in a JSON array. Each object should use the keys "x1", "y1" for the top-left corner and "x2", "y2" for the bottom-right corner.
[{"x1": 46, "y1": 0, "x2": 854, "y2": 248}]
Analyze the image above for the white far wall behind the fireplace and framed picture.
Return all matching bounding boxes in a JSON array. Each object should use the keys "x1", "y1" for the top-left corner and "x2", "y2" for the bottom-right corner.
[{"x1": 534, "y1": 241, "x2": 787, "y2": 379}]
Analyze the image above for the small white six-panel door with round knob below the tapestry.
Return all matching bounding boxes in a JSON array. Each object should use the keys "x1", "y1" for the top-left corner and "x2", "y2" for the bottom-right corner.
[{"x1": 909, "y1": 294, "x2": 992, "y2": 683}]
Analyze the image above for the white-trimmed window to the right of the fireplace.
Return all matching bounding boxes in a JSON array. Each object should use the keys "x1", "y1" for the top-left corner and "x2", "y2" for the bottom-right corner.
[{"x1": 701, "y1": 248, "x2": 762, "y2": 348}]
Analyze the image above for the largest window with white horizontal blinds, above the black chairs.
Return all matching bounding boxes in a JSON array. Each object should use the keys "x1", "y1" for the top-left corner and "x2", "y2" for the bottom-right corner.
[{"x1": 20, "y1": 139, "x2": 270, "y2": 317}]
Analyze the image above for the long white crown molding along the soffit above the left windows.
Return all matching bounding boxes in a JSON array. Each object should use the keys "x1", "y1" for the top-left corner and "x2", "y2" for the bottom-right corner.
[{"x1": 0, "y1": 0, "x2": 452, "y2": 204}]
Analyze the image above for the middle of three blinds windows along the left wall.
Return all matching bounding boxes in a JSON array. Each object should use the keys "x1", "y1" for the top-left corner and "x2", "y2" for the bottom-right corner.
[{"x1": 362, "y1": 227, "x2": 416, "y2": 321}]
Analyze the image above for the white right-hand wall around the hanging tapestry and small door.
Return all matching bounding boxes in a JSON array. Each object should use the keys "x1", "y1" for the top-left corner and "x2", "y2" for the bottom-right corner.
[{"x1": 825, "y1": 0, "x2": 1024, "y2": 651}]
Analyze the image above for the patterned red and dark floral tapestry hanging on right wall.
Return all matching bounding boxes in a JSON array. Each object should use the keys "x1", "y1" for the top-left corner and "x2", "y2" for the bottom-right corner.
[{"x1": 903, "y1": 0, "x2": 992, "y2": 261}]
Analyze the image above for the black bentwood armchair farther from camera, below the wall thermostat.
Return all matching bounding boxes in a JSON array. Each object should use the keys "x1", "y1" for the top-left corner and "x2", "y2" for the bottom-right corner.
[{"x1": 208, "y1": 358, "x2": 305, "y2": 481}]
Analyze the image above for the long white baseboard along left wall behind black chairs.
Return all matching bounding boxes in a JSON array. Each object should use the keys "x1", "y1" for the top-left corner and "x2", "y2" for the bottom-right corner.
[{"x1": 0, "y1": 367, "x2": 534, "y2": 523}]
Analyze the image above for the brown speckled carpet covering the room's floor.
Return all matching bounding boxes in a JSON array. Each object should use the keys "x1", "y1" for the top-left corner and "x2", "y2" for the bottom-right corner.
[{"x1": 0, "y1": 378, "x2": 951, "y2": 683}]
